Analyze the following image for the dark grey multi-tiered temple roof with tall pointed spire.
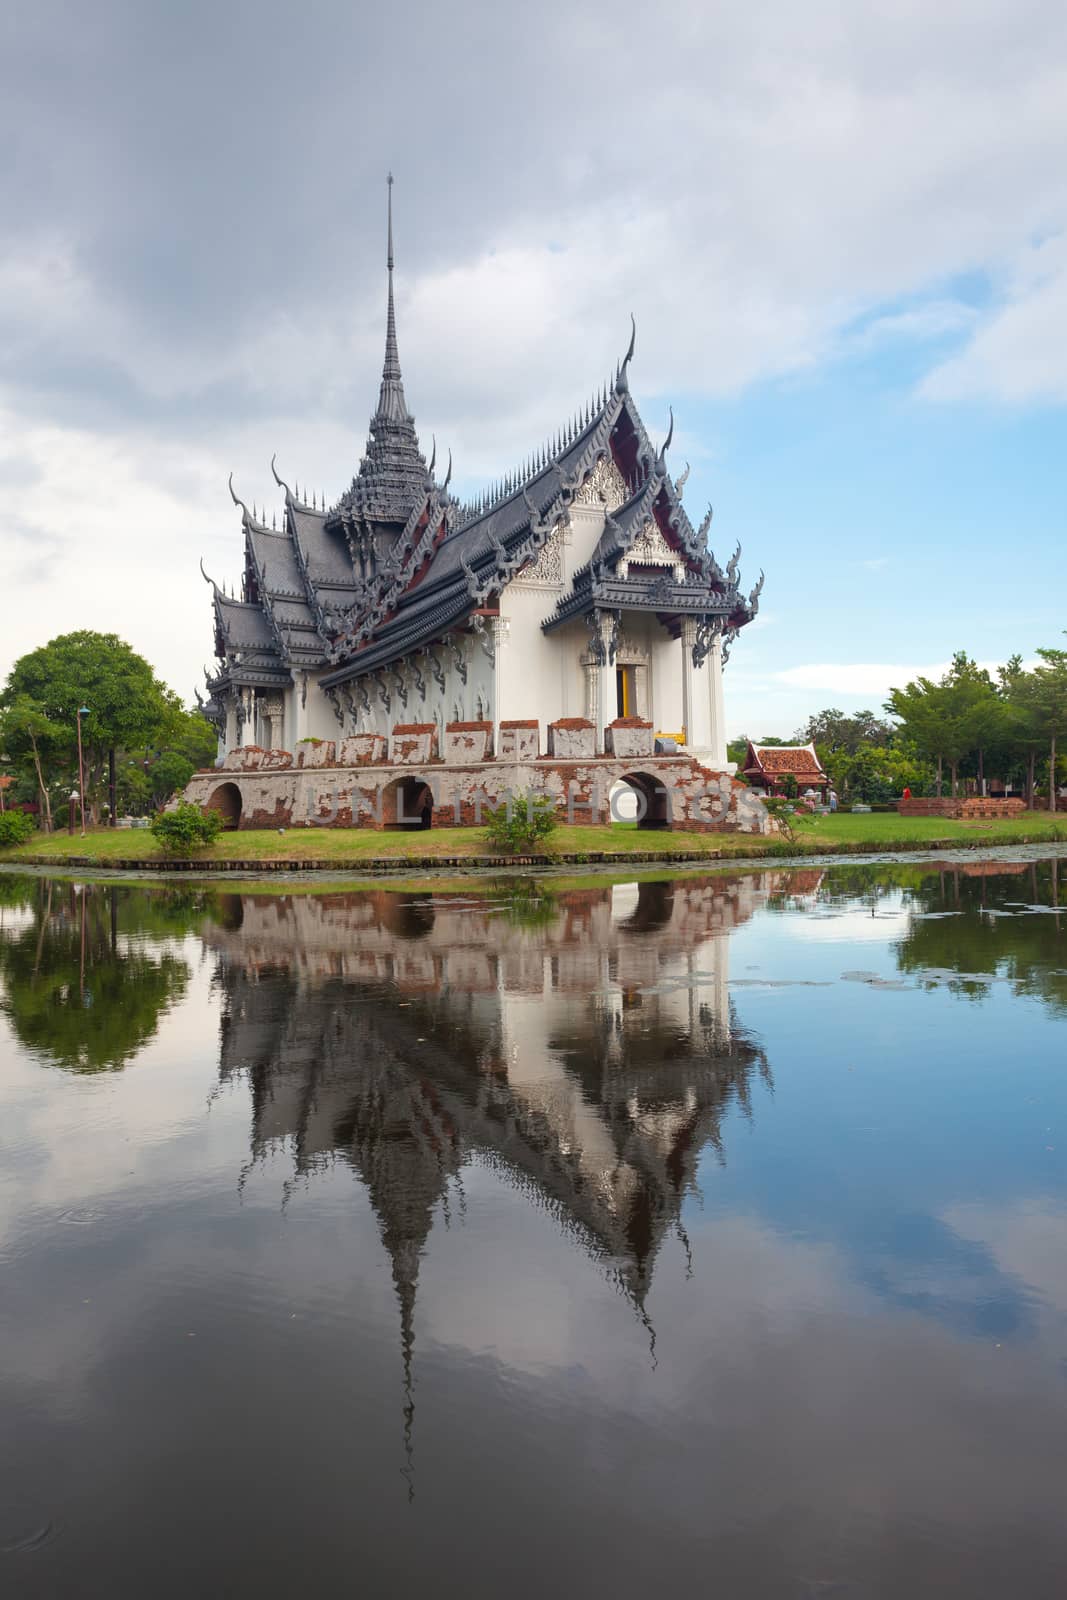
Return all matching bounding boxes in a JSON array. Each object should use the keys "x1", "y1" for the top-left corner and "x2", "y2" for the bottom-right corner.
[{"x1": 205, "y1": 179, "x2": 761, "y2": 713}]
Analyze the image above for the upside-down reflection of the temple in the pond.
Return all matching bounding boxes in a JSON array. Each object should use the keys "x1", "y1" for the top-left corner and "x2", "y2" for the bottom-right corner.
[{"x1": 206, "y1": 874, "x2": 774, "y2": 1323}]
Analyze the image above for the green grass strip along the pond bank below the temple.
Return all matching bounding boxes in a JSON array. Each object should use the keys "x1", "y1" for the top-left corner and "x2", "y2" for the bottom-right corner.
[{"x1": 0, "y1": 811, "x2": 1067, "y2": 867}]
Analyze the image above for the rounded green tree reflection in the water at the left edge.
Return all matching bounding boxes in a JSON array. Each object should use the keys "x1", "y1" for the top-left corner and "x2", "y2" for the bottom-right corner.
[{"x1": 0, "y1": 880, "x2": 191, "y2": 1072}]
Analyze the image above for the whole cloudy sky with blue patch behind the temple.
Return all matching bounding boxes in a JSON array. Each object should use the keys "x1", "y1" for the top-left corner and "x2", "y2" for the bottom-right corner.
[{"x1": 0, "y1": 0, "x2": 1067, "y2": 734}]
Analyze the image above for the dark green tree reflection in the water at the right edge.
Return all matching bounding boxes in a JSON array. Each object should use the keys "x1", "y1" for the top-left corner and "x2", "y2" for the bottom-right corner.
[{"x1": 896, "y1": 861, "x2": 1067, "y2": 1013}]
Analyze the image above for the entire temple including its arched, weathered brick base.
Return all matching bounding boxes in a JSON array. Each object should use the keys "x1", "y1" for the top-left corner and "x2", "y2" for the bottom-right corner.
[{"x1": 189, "y1": 178, "x2": 768, "y2": 832}]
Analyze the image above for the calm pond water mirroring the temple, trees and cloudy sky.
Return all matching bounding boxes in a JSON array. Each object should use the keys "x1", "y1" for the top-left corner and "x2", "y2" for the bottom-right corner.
[{"x1": 0, "y1": 861, "x2": 1067, "y2": 1600}]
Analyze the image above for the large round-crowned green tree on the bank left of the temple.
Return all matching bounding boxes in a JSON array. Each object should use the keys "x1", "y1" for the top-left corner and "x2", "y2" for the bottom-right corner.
[{"x1": 0, "y1": 630, "x2": 174, "y2": 824}]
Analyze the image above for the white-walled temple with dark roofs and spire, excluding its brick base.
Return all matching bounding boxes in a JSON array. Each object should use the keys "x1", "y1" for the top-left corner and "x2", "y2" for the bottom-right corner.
[{"x1": 199, "y1": 186, "x2": 761, "y2": 768}]
